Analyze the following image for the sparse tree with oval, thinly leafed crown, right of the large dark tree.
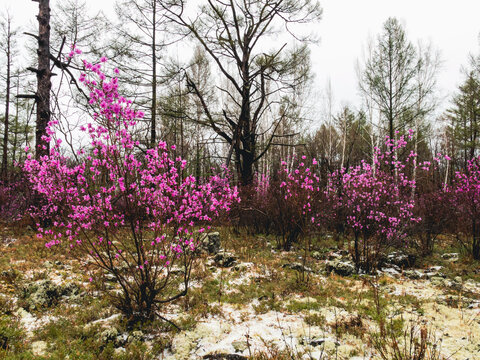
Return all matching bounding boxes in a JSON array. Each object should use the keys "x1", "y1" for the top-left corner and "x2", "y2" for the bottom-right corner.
[{"x1": 358, "y1": 18, "x2": 439, "y2": 176}]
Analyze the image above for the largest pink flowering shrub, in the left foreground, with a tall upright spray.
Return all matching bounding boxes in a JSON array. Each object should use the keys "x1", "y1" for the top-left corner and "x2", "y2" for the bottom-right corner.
[{"x1": 24, "y1": 58, "x2": 237, "y2": 320}]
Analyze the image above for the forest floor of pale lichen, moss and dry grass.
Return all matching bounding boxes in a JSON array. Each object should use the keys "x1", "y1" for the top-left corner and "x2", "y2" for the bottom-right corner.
[{"x1": 0, "y1": 227, "x2": 480, "y2": 360}]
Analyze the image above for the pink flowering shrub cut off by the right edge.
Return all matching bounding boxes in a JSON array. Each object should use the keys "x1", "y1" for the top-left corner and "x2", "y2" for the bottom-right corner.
[{"x1": 453, "y1": 156, "x2": 480, "y2": 260}]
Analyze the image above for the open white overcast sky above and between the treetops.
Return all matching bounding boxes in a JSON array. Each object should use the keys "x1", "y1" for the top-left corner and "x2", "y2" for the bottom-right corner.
[{"x1": 0, "y1": 0, "x2": 480, "y2": 115}]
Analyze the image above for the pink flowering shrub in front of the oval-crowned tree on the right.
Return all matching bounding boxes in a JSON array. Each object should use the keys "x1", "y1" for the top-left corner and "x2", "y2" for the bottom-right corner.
[{"x1": 328, "y1": 136, "x2": 429, "y2": 271}]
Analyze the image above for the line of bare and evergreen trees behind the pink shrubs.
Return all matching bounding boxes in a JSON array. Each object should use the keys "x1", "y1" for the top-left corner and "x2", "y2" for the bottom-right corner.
[{"x1": 0, "y1": 0, "x2": 480, "y2": 260}]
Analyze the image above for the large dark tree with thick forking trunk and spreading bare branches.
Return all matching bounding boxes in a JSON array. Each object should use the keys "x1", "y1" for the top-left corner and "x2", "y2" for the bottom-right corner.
[{"x1": 161, "y1": 0, "x2": 322, "y2": 185}]
